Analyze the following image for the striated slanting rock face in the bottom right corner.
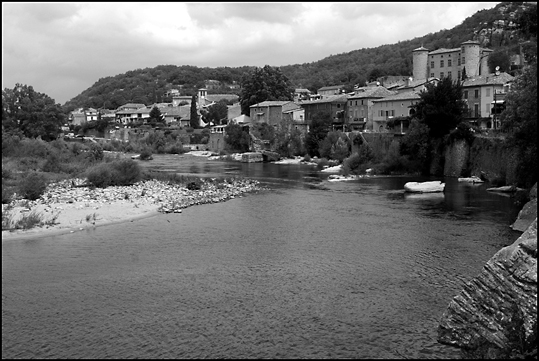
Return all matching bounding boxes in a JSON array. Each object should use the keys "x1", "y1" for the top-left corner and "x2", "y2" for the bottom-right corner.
[{"x1": 438, "y1": 218, "x2": 537, "y2": 357}]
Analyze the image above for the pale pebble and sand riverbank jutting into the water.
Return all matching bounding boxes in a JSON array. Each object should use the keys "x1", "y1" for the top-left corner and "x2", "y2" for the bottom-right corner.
[{"x1": 2, "y1": 179, "x2": 261, "y2": 240}]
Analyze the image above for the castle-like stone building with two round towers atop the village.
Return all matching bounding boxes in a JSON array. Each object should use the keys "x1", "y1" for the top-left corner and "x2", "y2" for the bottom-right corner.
[{"x1": 412, "y1": 40, "x2": 492, "y2": 80}]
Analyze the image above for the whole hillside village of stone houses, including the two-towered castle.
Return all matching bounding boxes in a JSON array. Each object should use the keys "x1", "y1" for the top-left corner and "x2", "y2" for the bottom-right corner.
[{"x1": 64, "y1": 40, "x2": 525, "y2": 152}]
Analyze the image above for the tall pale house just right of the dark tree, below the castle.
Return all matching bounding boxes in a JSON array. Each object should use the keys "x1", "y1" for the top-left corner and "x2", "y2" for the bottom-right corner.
[{"x1": 462, "y1": 72, "x2": 514, "y2": 129}]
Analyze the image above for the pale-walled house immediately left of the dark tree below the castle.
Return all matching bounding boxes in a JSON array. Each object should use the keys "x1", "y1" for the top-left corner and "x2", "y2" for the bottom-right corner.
[{"x1": 372, "y1": 91, "x2": 421, "y2": 133}]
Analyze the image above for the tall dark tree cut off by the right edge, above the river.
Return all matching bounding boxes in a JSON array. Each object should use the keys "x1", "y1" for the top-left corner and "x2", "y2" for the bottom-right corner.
[{"x1": 500, "y1": 63, "x2": 537, "y2": 187}]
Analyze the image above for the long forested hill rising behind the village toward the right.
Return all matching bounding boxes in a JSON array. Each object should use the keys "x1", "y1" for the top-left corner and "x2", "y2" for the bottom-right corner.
[{"x1": 64, "y1": 2, "x2": 537, "y2": 111}]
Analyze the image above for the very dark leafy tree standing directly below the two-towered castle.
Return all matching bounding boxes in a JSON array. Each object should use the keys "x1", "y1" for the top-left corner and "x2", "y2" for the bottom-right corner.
[{"x1": 412, "y1": 78, "x2": 466, "y2": 138}]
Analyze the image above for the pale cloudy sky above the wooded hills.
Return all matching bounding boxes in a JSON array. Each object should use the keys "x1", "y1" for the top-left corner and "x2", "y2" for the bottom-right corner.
[{"x1": 2, "y1": 2, "x2": 497, "y2": 104}]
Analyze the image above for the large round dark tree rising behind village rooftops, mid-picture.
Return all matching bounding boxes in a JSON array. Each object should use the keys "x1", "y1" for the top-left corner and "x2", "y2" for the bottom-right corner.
[{"x1": 239, "y1": 65, "x2": 294, "y2": 115}]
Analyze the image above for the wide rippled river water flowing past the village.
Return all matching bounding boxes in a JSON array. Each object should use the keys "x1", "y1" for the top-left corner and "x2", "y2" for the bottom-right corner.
[{"x1": 2, "y1": 155, "x2": 519, "y2": 358}]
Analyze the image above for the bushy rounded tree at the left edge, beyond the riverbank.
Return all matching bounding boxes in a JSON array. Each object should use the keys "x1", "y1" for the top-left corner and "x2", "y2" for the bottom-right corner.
[{"x1": 2, "y1": 83, "x2": 65, "y2": 141}]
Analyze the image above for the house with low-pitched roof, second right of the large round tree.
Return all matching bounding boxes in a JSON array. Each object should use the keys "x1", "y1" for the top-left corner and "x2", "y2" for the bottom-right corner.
[{"x1": 300, "y1": 94, "x2": 348, "y2": 130}]
